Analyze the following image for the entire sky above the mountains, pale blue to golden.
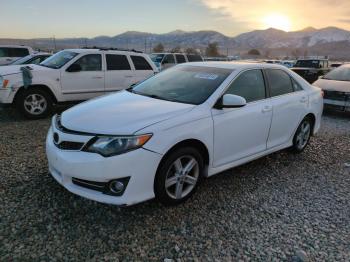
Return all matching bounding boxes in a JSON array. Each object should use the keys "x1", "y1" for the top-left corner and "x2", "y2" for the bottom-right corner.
[{"x1": 0, "y1": 0, "x2": 350, "y2": 39}]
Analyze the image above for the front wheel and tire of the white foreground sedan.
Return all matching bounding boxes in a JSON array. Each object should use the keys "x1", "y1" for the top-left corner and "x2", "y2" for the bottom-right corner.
[{"x1": 154, "y1": 147, "x2": 204, "y2": 206}]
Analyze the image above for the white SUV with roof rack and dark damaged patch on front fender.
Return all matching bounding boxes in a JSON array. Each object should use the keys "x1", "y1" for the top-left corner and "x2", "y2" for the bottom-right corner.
[{"x1": 0, "y1": 49, "x2": 158, "y2": 119}]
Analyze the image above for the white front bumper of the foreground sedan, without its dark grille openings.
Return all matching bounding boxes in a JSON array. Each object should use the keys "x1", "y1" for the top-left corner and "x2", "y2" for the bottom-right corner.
[{"x1": 46, "y1": 127, "x2": 162, "y2": 206}]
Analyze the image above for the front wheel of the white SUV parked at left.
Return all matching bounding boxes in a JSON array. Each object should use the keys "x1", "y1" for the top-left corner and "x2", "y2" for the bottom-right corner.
[{"x1": 17, "y1": 88, "x2": 52, "y2": 119}]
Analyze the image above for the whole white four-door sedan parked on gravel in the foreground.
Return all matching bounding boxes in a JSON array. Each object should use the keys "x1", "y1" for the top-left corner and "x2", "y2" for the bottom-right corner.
[{"x1": 46, "y1": 62, "x2": 323, "y2": 205}]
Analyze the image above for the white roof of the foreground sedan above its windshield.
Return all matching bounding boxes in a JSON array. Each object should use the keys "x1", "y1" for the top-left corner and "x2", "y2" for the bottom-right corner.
[{"x1": 182, "y1": 61, "x2": 286, "y2": 70}]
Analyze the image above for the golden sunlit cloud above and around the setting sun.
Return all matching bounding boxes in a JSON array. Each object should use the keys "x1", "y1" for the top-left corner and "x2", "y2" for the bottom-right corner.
[{"x1": 194, "y1": 0, "x2": 350, "y2": 30}]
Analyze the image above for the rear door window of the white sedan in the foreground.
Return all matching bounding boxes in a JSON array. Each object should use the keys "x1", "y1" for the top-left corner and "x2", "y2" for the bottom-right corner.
[{"x1": 266, "y1": 69, "x2": 294, "y2": 97}]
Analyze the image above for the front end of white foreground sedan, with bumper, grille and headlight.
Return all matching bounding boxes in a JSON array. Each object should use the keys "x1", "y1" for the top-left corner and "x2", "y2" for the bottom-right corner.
[{"x1": 46, "y1": 117, "x2": 162, "y2": 206}]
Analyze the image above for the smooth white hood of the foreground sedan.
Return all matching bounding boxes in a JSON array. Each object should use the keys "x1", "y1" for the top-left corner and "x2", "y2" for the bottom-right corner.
[{"x1": 61, "y1": 91, "x2": 195, "y2": 135}]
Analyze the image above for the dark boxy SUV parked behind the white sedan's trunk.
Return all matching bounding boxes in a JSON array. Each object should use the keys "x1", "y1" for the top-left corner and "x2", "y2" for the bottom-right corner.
[{"x1": 291, "y1": 59, "x2": 331, "y2": 84}]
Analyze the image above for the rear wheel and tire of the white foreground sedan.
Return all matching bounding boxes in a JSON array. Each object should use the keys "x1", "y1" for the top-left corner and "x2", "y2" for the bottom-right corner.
[{"x1": 291, "y1": 117, "x2": 313, "y2": 153}]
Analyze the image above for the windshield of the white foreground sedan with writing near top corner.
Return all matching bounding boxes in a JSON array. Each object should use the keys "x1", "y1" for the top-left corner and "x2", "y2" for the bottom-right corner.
[{"x1": 129, "y1": 65, "x2": 233, "y2": 105}]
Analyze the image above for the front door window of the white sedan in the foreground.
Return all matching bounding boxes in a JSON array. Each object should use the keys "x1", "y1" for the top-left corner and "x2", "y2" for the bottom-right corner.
[{"x1": 225, "y1": 69, "x2": 266, "y2": 103}]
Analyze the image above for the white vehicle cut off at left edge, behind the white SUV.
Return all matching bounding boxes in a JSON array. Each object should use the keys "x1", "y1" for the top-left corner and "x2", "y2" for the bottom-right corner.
[{"x1": 0, "y1": 45, "x2": 34, "y2": 65}]
